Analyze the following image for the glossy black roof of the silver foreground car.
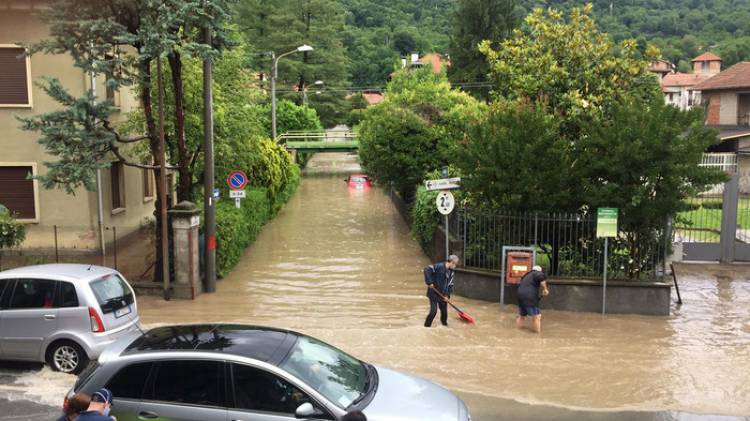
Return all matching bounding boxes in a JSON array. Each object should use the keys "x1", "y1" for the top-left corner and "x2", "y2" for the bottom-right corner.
[{"x1": 121, "y1": 324, "x2": 301, "y2": 365}]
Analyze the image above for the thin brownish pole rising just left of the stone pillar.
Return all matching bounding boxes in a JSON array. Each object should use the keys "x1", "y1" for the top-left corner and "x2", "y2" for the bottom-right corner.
[{"x1": 156, "y1": 57, "x2": 169, "y2": 300}]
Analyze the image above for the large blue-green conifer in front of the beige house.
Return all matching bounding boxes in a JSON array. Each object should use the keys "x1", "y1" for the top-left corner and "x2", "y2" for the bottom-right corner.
[{"x1": 21, "y1": 0, "x2": 231, "y2": 279}]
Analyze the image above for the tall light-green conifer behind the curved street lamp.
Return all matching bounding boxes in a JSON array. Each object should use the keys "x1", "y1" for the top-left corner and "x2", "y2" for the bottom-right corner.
[{"x1": 237, "y1": 0, "x2": 350, "y2": 126}]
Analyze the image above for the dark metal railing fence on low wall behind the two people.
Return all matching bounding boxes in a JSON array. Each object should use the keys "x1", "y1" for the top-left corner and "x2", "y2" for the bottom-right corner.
[{"x1": 450, "y1": 209, "x2": 671, "y2": 280}]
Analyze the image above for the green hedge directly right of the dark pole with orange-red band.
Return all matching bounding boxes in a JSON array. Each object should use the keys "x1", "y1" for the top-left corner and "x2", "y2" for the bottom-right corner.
[{"x1": 216, "y1": 189, "x2": 271, "y2": 278}]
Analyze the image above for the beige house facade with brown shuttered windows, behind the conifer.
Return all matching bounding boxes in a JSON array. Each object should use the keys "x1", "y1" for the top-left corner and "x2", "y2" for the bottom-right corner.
[{"x1": 0, "y1": 0, "x2": 155, "y2": 251}]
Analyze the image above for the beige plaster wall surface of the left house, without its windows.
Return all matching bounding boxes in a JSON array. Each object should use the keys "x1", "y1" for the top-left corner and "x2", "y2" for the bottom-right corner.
[{"x1": 0, "y1": 8, "x2": 153, "y2": 249}]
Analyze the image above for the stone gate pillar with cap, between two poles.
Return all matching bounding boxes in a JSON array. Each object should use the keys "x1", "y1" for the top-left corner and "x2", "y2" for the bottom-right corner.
[{"x1": 169, "y1": 201, "x2": 203, "y2": 299}]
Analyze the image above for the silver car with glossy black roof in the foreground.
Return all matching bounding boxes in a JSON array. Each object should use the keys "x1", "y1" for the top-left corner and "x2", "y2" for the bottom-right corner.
[{"x1": 66, "y1": 324, "x2": 471, "y2": 421}]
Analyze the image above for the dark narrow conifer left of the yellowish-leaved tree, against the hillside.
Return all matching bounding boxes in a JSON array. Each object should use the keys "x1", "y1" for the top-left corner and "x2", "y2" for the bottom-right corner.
[{"x1": 448, "y1": 0, "x2": 520, "y2": 99}]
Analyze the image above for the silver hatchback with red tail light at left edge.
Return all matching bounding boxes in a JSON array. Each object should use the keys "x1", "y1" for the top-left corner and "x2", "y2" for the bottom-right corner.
[{"x1": 0, "y1": 264, "x2": 139, "y2": 374}]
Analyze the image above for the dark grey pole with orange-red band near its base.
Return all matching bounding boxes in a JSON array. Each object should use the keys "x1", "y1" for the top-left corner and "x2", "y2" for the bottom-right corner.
[{"x1": 203, "y1": 25, "x2": 217, "y2": 292}]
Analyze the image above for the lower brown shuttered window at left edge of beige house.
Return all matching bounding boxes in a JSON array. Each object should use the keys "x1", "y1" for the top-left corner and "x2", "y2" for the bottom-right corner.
[{"x1": 0, "y1": 165, "x2": 37, "y2": 219}]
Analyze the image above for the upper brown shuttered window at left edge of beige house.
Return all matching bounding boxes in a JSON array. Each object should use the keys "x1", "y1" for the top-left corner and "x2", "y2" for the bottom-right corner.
[{"x1": 0, "y1": 45, "x2": 31, "y2": 107}]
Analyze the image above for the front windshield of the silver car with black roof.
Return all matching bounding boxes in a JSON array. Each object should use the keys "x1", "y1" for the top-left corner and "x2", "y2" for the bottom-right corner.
[{"x1": 281, "y1": 336, "x2": 368, "y2": 408}]
